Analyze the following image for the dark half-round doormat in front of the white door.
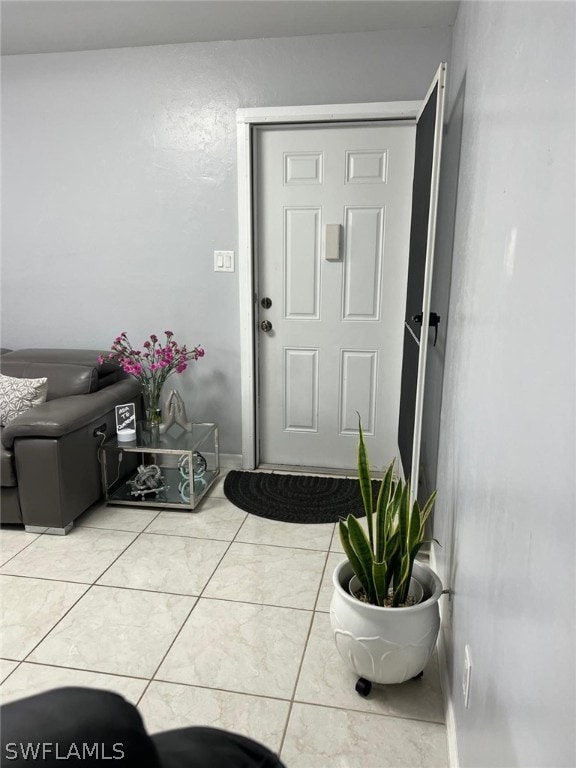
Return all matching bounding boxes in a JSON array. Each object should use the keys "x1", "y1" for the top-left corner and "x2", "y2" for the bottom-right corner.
[{"x1": 224, "y1": 470, "x2": 364, "y2": 523}]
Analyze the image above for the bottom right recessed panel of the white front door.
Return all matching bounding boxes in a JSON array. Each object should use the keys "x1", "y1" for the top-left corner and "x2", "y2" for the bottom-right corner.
[{"x1": 339, "y1": 349, "x2": 378, "y2": 435}]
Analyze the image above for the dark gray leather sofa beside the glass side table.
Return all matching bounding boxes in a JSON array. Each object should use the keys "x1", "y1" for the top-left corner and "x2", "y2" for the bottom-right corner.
[{"x1": 0, "y1": 349, "x2": 141, "y2": 533}]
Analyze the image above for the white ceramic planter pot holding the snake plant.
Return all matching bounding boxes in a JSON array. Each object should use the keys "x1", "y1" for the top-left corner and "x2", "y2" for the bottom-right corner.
[{"x1": 330, "y1": 560, "x2": 442, "y2": 684}]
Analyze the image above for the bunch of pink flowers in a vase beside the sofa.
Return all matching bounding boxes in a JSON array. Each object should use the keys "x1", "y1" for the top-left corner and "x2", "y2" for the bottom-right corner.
[{"x1": 98, "y1": 331, "x2": 204, "y2": 420}]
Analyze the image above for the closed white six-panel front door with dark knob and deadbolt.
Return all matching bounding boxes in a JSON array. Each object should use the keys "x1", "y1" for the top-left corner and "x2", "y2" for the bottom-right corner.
[{"x1": 255, "y1": 123, "x2": 415, "y2": 469}]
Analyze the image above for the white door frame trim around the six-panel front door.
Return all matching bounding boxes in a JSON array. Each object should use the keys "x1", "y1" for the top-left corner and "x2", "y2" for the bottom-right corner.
[{"x1": 236, "y1": 100, "x2": 422, "y2": 469}]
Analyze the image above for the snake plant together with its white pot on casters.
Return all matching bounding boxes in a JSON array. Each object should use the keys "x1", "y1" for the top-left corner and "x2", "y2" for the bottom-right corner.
[{"x1": 330, "y1": 423, "x2": 442, "y2": 696}]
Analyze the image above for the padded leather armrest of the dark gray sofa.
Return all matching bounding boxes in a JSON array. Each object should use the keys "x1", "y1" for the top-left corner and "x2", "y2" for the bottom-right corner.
[{"x1": 2, "y1": 378, "x2": 142, "y2": 448}]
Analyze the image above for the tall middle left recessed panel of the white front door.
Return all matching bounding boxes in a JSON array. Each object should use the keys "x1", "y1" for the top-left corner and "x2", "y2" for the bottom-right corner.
[{"x1": 284, "y1": 208, "x2": 321, "y2": 320}]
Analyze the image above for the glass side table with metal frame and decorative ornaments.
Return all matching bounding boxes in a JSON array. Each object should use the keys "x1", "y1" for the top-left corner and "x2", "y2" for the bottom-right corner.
[{"x1": 102, "y1": 422, "x2": 220, "y2": 511}]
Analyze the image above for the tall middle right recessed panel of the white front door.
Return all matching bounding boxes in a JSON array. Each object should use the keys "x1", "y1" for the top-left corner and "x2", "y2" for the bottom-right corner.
[{"x1": 342, "y1": 207, "x2": 385, "y2": 321}]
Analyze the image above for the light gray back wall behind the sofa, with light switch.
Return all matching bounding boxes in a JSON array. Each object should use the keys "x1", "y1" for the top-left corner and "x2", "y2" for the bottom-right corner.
[{"x1": 2, "y1": 29, "x2": 450, "y2": 453}]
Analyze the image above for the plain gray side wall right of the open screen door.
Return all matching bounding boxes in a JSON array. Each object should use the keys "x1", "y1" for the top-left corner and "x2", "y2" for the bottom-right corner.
[{"x1": 435, "y1": 2, "x2": 576, "y2": 768}]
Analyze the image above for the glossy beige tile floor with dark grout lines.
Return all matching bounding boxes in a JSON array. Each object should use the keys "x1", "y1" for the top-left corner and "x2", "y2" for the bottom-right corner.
[{"x1": 0, "y1": 478, "x2": 448, "y2": 768}]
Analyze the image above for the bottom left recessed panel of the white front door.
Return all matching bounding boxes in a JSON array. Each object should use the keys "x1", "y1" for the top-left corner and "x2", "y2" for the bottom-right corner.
[{"x1": 284, "y1": 348, "x2": 319, "y2": 432}]
